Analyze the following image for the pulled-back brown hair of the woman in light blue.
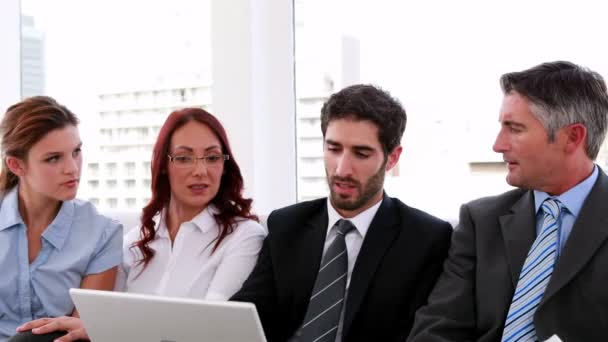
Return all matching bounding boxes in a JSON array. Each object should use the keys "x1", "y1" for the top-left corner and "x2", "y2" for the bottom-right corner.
[{"x1": 0, "y1": 96, "x2": 78, "y2": 193}]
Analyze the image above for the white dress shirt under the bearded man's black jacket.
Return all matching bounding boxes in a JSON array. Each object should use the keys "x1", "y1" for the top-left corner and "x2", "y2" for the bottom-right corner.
[{"x1": 323, "y1": 198, "x2": 382, "y2": 342}]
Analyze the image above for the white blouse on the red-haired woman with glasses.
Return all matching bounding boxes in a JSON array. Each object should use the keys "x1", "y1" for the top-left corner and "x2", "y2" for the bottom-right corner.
[{"x1": 115, "y1": 206, "x2": 266, "y2": 300}]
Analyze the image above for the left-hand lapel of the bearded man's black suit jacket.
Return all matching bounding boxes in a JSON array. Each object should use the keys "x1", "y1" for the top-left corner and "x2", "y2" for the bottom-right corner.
[{"x1": 285, "y1": 204, "x2": 328, "y2": 319}]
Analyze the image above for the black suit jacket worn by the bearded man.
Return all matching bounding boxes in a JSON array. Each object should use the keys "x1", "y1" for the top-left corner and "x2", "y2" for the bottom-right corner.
[{"x1": 232, "y1": 195, "x2": 452, "y2": 342}]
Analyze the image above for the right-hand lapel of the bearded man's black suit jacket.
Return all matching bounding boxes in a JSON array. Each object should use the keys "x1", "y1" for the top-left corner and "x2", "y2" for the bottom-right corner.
[{"x1": 343, "y1": 195, "x2": 400, "y2": 337}]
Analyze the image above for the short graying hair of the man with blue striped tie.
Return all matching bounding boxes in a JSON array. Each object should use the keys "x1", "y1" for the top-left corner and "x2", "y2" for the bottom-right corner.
[{"x1": 500, "y1": 61, "x2": 608, "y2": 160}]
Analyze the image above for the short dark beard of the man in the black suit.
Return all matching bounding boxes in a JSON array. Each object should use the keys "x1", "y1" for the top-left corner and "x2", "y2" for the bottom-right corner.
[{"x1": 325, "y1": 164, "x2": 386, "y2": 211}]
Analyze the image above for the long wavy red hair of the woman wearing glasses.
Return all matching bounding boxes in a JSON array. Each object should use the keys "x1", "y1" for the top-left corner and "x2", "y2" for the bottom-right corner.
[{"x1": 131, "y1": 108, "x2": 258, "y2": 267}]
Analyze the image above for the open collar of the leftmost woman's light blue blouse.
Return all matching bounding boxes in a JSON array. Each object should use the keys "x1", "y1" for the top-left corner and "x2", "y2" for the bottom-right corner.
[{"x1": 0, "y1": 185, "x2": 74, "y2": 249}]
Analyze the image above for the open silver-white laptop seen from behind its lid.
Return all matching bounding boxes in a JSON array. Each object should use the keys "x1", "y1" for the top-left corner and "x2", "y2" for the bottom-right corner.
[{"x1": 70, "y1": 289, "x2": 266, "y2": 342}]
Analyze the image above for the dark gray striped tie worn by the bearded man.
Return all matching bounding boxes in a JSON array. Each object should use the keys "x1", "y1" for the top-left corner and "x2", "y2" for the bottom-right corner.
[{"x1": 299, "y1": 220, "x2": 355, "y2": 342}]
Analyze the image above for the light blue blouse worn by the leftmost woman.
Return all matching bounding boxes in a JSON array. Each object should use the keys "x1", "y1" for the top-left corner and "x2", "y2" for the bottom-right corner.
[{"x1": 0, "y1": 187, "x2": 122, "y2": 341}]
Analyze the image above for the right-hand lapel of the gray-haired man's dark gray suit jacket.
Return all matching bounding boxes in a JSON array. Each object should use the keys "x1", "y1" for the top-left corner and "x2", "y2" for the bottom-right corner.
[{"x1": 541, "y1": 169, "x2": 608, "y2": 305}]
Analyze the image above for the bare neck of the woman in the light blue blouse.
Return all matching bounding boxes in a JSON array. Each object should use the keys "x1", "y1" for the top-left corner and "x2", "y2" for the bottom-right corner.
[{"x1": 17, "y1": 185, "x2": 61, "y2": 231}]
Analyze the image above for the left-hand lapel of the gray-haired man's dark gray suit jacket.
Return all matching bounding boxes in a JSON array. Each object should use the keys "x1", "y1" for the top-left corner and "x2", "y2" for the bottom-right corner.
[{"x1": 498, "y1": 191, "x2": 536, "y2": 288}]
